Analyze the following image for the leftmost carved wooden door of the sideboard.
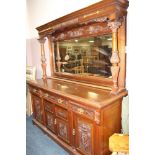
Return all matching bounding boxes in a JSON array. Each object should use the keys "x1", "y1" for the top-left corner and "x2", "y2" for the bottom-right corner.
[{"x1": 32, "y1": 95, "x2": 43, "y2": 123}]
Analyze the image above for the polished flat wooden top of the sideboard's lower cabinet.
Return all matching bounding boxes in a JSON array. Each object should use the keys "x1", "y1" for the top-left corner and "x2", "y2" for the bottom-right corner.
[{"x1": 27, "y1": 79, "x2": 127, "y2": 108}]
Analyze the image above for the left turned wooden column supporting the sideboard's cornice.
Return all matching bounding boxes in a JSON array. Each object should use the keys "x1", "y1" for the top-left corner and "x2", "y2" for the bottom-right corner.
[{"x1": 38, "y1": 38, "x2": 47, "y2": 79}]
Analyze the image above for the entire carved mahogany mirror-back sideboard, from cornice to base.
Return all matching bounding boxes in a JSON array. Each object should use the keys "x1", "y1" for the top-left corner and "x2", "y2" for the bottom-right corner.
[{"x1": 27, "y1": 0, "x2": 128, "y2": 155}]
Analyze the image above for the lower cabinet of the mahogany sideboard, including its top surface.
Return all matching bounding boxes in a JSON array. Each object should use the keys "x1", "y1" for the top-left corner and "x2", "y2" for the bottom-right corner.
[{"x1": 28, "y1": 79, "x2": 127, "y2": 155}]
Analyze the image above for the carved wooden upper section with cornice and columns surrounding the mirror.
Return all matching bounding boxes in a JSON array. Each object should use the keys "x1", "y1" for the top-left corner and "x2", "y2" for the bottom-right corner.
[{"x1": 36, "y1": 0, "x2": 128, "y2": 94}]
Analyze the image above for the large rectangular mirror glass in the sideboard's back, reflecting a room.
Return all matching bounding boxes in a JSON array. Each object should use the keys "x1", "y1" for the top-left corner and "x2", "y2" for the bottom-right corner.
[{"x1": 55, "y1": 34, "x2": 112, "y2": 78}]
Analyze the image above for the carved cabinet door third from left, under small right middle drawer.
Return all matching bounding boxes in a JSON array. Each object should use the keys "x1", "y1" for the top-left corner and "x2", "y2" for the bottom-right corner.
[{"x1": 56, "y1": 118, "x2": 70, "y2": 143}]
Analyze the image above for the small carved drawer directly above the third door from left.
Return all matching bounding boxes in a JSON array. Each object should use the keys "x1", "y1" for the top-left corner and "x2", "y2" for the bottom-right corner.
[{"x1": 55, "y1": 106, "x2": 68, "y2": 120}]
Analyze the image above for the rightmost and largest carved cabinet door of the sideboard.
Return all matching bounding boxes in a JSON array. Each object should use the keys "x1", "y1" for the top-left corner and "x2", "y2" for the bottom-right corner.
[{"x1": 74, "y1": 115, "x2": 94, "y2": 155}]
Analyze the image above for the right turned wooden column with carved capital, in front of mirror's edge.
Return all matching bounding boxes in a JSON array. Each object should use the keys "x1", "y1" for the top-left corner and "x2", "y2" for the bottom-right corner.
[{"x1": 108, "y1": 21, "x2": 121, "y2": 94}]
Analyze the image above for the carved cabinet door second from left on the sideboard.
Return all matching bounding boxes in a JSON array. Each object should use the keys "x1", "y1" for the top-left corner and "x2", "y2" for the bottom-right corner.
[{"x1": 45, "y1": 111, "x2": 56, "y2": 133}]
